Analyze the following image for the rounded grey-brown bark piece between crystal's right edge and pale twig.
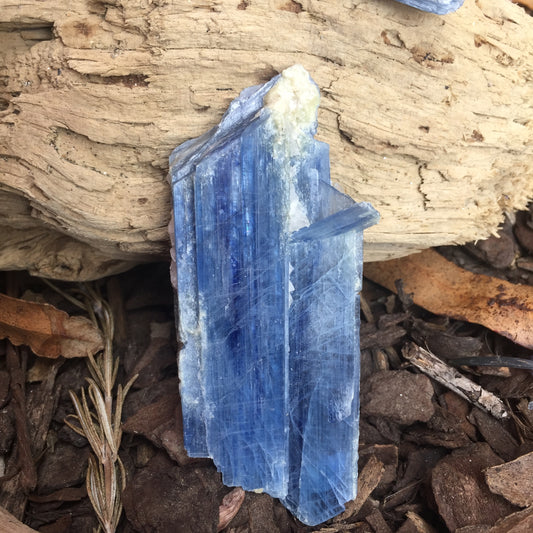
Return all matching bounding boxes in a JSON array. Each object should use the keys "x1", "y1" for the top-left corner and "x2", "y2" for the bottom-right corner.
[{"x1": 361, "y1": 370, "x2": 435, "y2": 425}]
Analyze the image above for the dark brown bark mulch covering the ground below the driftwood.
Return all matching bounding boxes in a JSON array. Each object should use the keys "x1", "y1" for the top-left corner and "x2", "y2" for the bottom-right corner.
[{"x1": 0, "y1": 206, "x2": 533, "y2": 533}]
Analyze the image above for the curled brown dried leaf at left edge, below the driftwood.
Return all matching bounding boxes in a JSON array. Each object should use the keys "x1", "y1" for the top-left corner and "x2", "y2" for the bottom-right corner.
[{"x1": 0, "y1": 294, "x2": 103, "y2": 358}]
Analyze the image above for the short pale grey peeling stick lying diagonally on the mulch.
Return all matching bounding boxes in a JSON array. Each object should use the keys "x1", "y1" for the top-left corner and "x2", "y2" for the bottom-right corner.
[{"x1": 402, "y1": 343, "x2": 509, "y2": 418}]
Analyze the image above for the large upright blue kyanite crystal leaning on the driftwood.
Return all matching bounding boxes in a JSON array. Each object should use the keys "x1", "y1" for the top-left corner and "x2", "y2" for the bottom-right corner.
[{"x1": 170, "y1": 65, "x2": 378, "y2": 525}]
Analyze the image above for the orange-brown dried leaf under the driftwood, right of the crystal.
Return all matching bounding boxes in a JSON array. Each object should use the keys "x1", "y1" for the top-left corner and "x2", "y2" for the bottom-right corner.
[{"x1": 364, "y1": 250, "x2": 533, "y2": 348}]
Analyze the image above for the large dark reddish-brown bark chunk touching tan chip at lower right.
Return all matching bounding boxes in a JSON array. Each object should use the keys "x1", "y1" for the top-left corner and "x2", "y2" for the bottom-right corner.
[{"x1": 431, "y1": 443, "x2": 513, "y2": 531}]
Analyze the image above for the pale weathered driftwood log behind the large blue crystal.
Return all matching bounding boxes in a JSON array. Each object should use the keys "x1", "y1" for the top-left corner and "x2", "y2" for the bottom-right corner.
[{"x1": 0, "y1": 0, "x2": 533, "y2": 279}]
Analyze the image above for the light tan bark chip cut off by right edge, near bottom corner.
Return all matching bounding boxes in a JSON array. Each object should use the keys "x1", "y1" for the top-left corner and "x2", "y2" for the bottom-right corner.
[{"x1": 485, "y1": 452, "x2": 533, "y2": 507}]
